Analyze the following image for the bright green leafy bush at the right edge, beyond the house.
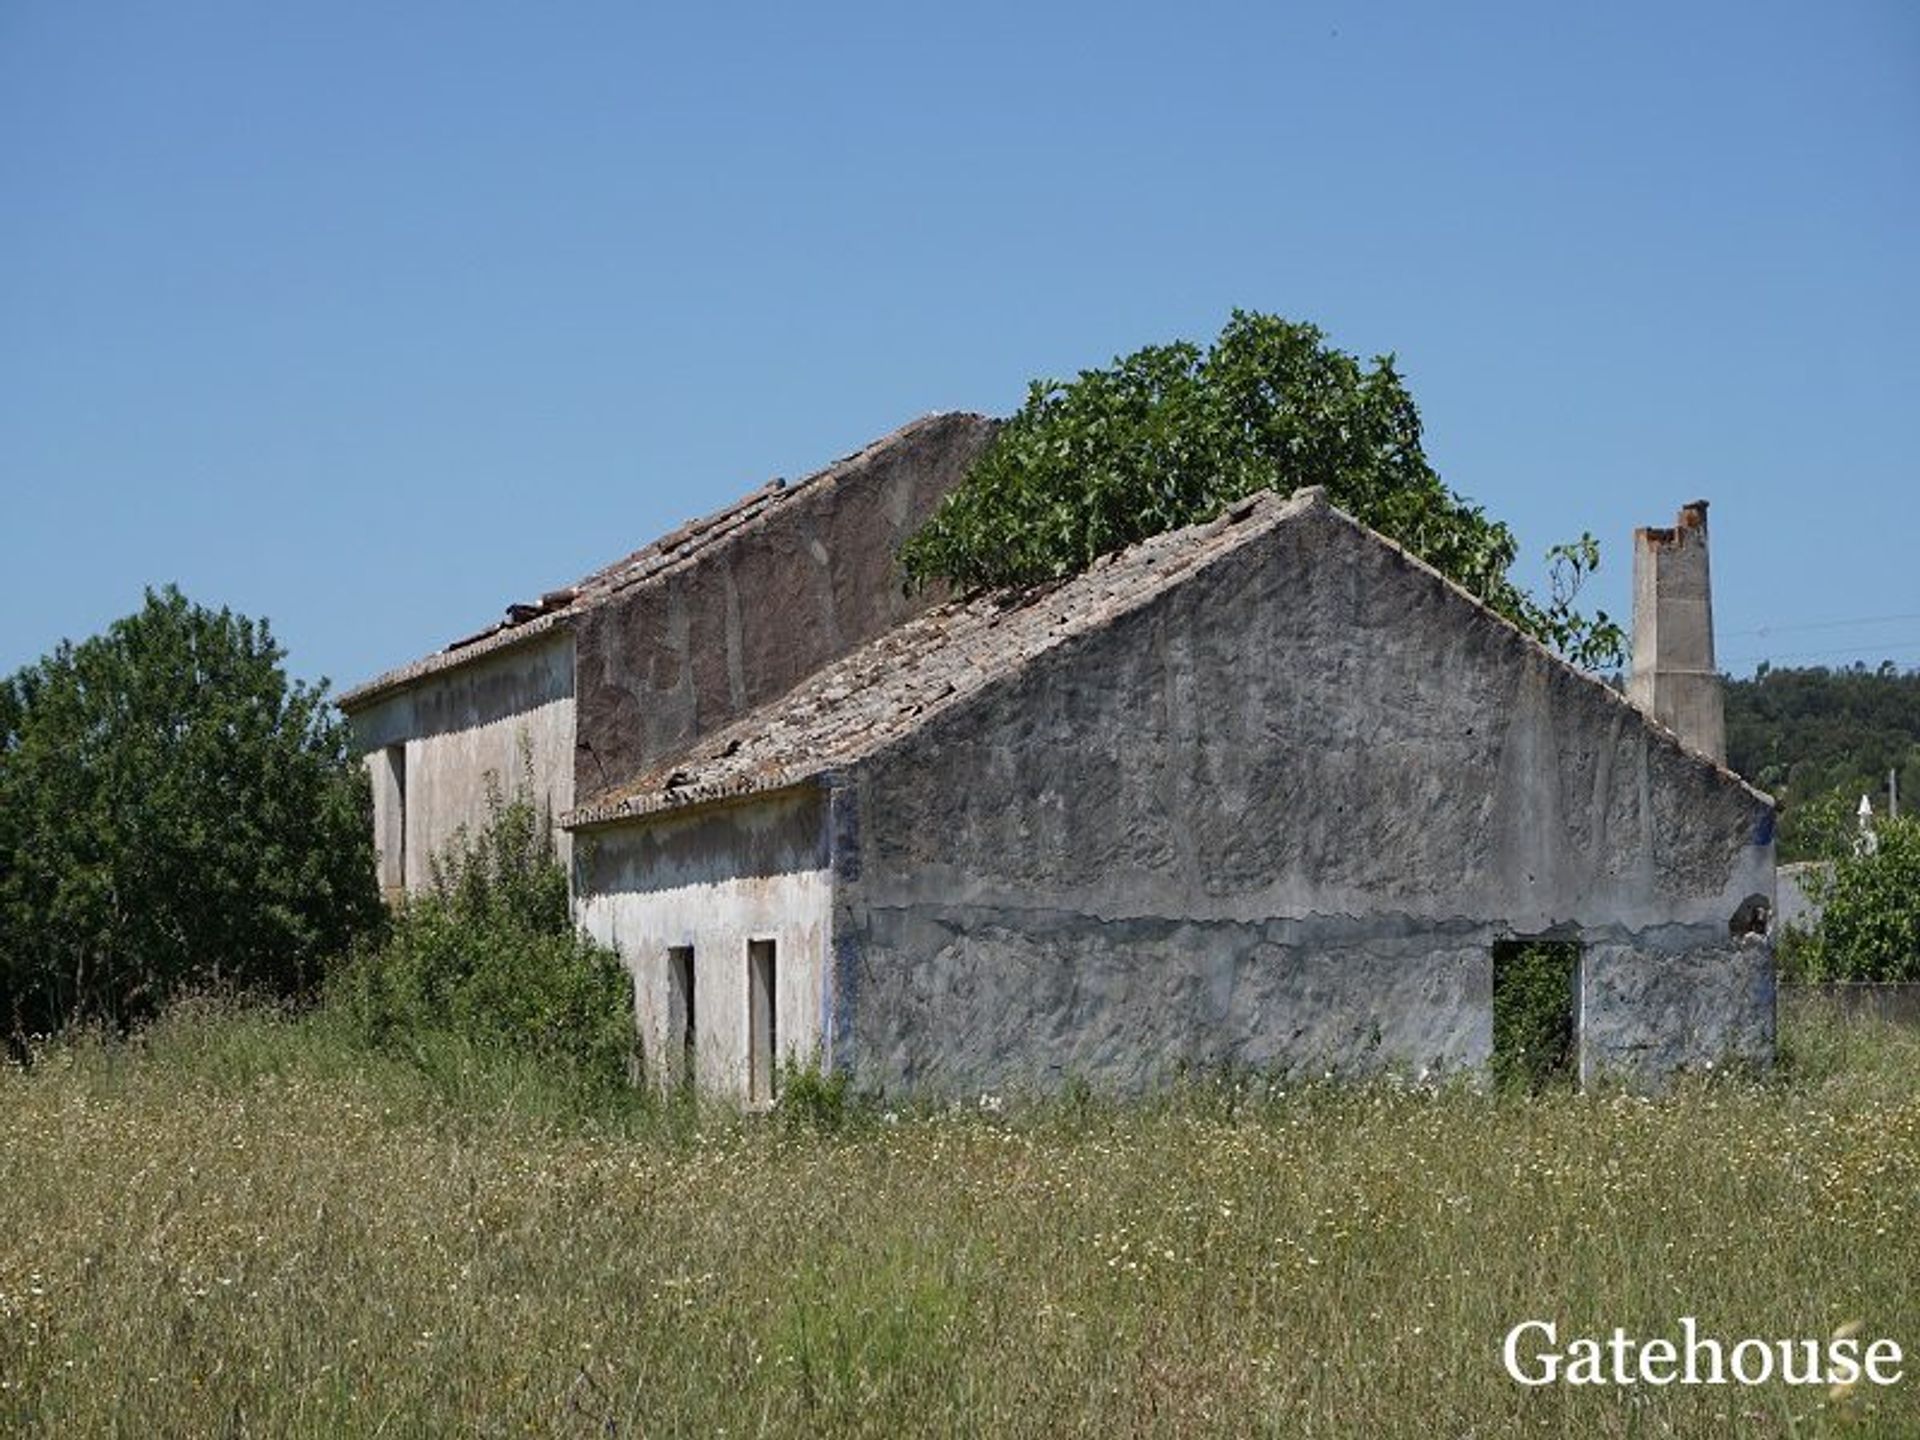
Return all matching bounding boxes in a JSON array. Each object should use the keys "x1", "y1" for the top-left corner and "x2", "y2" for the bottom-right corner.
[{"x1": 1799, "y1": 816, "x2": 1920, "y2": 981}]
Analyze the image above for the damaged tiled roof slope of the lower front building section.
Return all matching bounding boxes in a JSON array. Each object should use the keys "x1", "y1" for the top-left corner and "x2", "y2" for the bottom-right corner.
[{"x1": 561, "y1": 486, "x2": 1327, "y2": 829}]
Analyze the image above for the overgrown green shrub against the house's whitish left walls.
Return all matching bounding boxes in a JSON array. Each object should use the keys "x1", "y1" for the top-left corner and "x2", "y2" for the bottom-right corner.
[{"x1": 328, "y1": 785, "x2": 636, "y2": 1087}]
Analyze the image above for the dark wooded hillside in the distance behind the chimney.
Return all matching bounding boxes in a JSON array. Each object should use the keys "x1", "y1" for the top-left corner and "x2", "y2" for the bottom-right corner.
[{"x1": 1726, "y1": 664, "x2": 1920, "y2": 860}]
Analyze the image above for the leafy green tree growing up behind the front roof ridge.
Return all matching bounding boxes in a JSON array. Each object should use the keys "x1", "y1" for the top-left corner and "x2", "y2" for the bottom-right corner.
[{"x1": 900, "y1": 311, "x2": 1624, "y2": 666}]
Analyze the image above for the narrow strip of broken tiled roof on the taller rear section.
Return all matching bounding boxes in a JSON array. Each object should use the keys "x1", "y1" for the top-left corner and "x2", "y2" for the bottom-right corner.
[{"x1": 334, "y1": 413, "x2": 983, "y2": 710}]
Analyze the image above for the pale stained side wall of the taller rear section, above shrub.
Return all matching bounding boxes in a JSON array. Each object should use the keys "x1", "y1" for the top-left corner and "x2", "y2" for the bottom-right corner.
[{"x1": 351, "y1": 632, "x2": 574, "y2": 889}]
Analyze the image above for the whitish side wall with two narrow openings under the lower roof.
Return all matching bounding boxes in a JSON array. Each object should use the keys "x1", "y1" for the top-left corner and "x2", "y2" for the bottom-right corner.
[{"x1": 574, "y1": 789, "x2": 831, "y2": 1100}]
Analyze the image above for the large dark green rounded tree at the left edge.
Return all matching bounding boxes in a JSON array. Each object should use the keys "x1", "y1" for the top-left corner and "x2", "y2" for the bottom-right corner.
[{"x1": 0, "y1": 588, "x2": 380, "y2": 1035}]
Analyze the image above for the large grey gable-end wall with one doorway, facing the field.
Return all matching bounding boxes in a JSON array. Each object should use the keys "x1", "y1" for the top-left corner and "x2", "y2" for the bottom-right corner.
[{"x1": 833, "y1": 509, "x2": 1772, "y2": 1092}]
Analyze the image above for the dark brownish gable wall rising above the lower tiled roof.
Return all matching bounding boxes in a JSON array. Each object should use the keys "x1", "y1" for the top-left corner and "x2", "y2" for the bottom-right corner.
[{"x1": 576, "y1": 415, "x2": 995, "y2": 803}]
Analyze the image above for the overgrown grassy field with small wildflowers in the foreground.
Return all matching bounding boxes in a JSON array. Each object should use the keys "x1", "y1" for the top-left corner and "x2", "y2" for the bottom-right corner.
[{"x1": 0, "y1": 1010, "x2": 1920, "y2": 1436}]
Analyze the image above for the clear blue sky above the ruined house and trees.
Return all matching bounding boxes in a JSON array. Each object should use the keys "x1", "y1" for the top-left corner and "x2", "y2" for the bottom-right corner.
[{"x1": 0, "y1": 0, "x2": 1920, "y2": 685}]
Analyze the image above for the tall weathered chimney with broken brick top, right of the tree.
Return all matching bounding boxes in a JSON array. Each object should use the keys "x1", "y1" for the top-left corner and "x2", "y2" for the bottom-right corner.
[{"x1": 1626, "y1": 499, "x2": 1726, "y2": 764}]
